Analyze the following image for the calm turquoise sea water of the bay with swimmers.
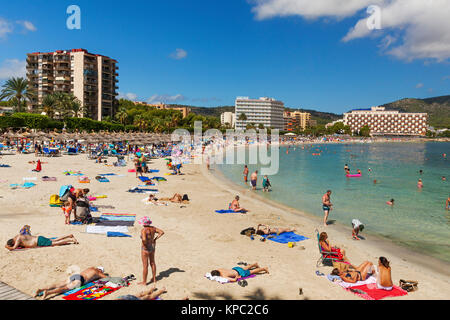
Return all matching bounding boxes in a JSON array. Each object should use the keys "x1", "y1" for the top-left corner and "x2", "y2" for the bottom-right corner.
[{"x1": 216, "y1": 142, "x2": 450, "y2": 262}]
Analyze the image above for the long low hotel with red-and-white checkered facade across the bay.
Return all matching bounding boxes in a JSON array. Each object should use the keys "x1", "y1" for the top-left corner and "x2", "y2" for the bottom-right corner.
[{"x1": 344, "y1": 107, "x2": 428, "y2": 136}]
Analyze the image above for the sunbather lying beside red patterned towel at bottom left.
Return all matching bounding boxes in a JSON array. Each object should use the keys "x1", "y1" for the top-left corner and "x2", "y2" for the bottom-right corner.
[{"x1": 34, "y1": 267, "x2": 108, "y2": 300}]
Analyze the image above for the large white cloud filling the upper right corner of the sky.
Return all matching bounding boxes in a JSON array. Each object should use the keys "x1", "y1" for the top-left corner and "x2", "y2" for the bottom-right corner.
[{"x1": 252, "y1": 0, "x2": 450, "y2": 62}]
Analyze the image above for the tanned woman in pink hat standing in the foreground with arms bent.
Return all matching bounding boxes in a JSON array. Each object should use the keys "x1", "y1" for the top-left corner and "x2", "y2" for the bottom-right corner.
[{"x1": 139, "y1": 217, "x2": 164, "y2": 286}]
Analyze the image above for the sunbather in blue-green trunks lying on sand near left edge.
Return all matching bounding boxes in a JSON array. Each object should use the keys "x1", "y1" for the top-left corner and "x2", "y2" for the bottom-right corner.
[{"x1": 5, "y1": 234, "x2": 78, "y2": 251}]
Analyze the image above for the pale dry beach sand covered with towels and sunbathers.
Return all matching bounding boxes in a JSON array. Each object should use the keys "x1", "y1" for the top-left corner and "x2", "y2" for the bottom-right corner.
[{"x1": 0, "y1": 155, "x2": 450, "y2": 300}]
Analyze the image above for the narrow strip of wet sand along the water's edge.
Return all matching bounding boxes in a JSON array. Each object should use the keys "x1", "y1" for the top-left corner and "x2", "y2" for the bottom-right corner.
[{"x1": 207, "y1": 162, "x2": 450, "y2": 277}]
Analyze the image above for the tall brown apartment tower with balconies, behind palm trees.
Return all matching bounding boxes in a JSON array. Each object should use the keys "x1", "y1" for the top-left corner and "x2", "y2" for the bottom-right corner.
[{"x1": 27, "y1": 49, "x2": 119, "y2": 120}]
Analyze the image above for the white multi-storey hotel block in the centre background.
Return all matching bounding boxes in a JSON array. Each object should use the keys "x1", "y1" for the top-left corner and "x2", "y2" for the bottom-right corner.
[{"x1": 235, "y1": 97, "x2": 284, "y2": 130}]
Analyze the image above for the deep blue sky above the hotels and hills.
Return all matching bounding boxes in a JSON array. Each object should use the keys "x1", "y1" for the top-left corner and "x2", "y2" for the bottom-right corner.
[{"x1": 0, "y1": 0, "x2": 450, "y2": 113}]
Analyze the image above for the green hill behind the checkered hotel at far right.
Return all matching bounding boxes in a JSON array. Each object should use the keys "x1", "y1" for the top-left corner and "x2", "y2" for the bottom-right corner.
[{"x1": 382, "y1": 96, "x2": 450, "y2": 129}]
